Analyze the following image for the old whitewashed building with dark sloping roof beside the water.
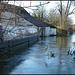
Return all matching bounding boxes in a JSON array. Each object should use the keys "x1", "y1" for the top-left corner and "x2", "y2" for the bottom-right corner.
[{"x1": 0, "y1": 3, "x2": 56, "y2": 40}]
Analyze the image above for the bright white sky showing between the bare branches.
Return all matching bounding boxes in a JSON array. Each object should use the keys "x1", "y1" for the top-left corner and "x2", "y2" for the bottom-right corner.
[{"x1": 9, "y1": 1, "x2": 75, "y2": 24}]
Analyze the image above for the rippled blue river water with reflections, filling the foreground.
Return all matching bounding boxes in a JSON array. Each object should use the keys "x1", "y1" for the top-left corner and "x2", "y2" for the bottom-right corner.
[{"x1": 0, "y1": 34, "x2": 75, "y2": 74}]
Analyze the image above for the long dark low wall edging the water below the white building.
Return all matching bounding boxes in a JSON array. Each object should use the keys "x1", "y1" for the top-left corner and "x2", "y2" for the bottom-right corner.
[{"x1": 0, "y1": 36, "x2": 39, "y2": 59}]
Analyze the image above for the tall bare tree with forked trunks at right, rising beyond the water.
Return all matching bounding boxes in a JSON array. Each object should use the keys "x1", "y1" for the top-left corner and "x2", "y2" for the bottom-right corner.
[{"x1": 59, "y1": 0, "x2": 75, "y2": 29}]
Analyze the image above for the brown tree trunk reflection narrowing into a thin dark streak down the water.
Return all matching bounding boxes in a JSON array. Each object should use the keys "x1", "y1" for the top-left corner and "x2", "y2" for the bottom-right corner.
[{"x1": 57, "y1": 37, "x2": 67, "y2": 73}]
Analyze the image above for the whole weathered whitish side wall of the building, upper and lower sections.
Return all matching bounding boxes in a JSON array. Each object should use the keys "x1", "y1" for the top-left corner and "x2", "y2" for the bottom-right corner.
[{"x1": 1, "y1": 12, "x2": 37, "y2": 40}]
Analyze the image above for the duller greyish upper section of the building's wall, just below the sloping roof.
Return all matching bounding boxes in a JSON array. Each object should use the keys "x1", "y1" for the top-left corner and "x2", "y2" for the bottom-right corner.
[{"x1": 1, "y1": 12, "x2": 35, "y2": 26}]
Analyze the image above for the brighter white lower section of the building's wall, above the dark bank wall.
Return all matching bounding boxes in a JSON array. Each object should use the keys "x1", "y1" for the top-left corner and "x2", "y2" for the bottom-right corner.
[{"x1": 3, "y1": 26, "x2": 37, "y2": 40}]
